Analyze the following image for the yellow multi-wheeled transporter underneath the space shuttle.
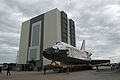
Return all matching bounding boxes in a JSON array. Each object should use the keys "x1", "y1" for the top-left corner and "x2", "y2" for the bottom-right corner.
[{"x1": 44, "y1": 62, "x2": 92, "y2": 72}]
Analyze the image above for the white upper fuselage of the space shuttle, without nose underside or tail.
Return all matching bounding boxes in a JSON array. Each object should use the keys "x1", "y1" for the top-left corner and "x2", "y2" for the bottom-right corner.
[{"x1": 52, "y1": 42, "x2": 92, "y2": 60}]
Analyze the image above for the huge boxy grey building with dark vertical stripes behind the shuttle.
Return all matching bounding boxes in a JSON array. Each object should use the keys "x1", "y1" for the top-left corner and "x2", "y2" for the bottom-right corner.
[{"x1": 17, "y1": 8, "x2": 76, "y2": 70}]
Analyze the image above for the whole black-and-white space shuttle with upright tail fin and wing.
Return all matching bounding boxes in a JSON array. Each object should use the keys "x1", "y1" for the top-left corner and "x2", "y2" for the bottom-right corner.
[{"x1": 43, "y1": 40, "x2": 110, "y2": 65}]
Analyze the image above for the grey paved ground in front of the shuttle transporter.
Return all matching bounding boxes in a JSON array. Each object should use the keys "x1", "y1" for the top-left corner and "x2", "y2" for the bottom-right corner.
[{"x1": 0, "y1": 69, "x2": 120, "y2": 80}]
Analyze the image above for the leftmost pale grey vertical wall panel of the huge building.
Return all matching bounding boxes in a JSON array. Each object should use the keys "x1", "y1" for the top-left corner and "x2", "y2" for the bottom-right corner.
[{"x1": 17, "y1": 20, "x2": 30, "y2": 64}]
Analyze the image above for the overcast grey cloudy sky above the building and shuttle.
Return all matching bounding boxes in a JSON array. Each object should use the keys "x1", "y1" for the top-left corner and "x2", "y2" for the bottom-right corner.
[{"x1": 0, "y1": 0, "x2": 120, "y2": 63}]
